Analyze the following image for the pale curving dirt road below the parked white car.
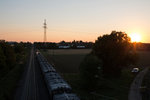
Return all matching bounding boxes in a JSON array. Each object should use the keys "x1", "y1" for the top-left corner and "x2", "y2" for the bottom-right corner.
[{"x1": 128, "y1": 67, "x2": 148, "y2": 100}]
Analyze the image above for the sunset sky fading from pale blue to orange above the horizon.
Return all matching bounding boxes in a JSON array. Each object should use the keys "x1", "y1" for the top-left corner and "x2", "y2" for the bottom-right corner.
[{"x1": 0, "y1": 0, "x2": 150, "y2": 43}]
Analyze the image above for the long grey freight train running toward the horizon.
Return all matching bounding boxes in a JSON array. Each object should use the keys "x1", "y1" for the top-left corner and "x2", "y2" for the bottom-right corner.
[{"x1": 36, "y1": 51, "x2": 80, "y2": 100}]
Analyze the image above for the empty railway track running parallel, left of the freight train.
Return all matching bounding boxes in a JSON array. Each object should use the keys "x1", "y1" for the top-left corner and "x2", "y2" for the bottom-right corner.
[{"x1": 22, "y1": 47, "x2": 39, "y2": 100}]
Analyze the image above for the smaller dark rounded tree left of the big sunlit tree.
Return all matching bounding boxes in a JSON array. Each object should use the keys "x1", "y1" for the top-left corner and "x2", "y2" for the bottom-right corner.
[{"x1": 80, "y1": 54, "x2": 102, "y2": 90}]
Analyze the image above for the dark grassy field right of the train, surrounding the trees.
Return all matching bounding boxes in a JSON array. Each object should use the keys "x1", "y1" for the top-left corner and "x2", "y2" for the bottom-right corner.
[{"x1": 41, "y1": 49, "x2": 150, "y2": 100}]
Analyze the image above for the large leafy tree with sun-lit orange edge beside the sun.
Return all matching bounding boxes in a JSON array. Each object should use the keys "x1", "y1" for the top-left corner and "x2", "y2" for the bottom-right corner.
[{"x1": 92, "y1": 31, "x2": 137, "y2": 76}]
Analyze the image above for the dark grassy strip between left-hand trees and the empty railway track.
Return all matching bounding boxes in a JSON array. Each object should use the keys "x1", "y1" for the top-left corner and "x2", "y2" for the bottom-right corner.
[{"x1": 0, "y1": 50, "x2": 29, "y2": 100}]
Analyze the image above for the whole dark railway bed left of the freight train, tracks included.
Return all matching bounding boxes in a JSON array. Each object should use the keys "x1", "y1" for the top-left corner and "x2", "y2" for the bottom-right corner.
[{"x1": 15, "y1": 47, "x2": 50, "y2": 100}]
